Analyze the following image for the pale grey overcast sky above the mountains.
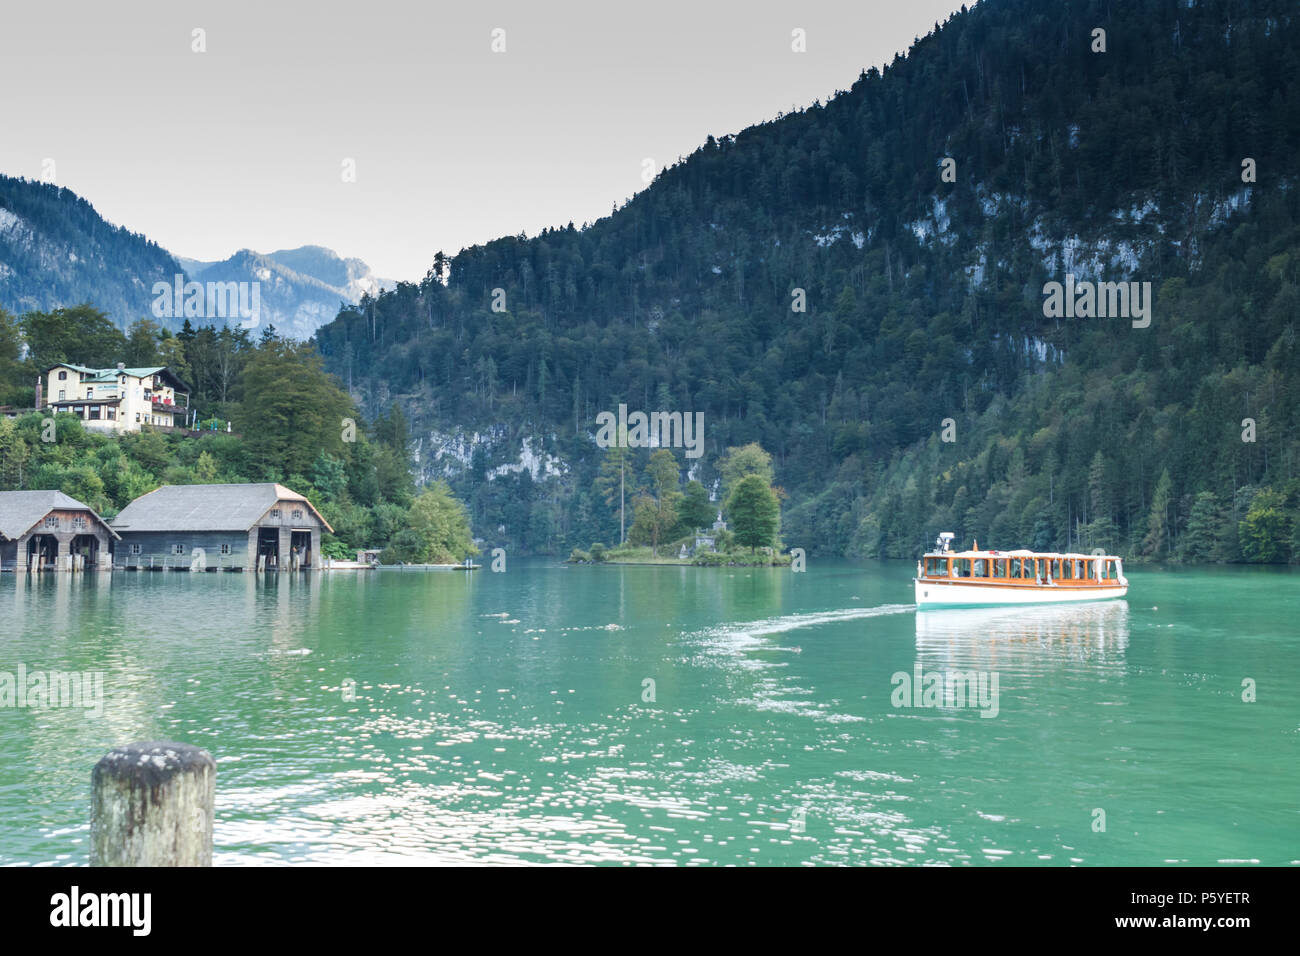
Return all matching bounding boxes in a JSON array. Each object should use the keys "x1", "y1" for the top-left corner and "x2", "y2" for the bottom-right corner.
[{"x1": 0, "y1": 0, "x2": 961, "y2": 280}]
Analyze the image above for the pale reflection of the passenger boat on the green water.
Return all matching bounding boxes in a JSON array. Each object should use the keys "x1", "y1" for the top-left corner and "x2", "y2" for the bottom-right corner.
[{"x1": 917, "y1": 600, "x2": 1128, "y2": 672}]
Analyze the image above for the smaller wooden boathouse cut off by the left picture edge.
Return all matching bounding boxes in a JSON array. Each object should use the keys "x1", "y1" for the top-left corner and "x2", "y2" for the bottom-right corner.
[{"x1": 0, "y1": 492, "x2": 117, "y2": 571}]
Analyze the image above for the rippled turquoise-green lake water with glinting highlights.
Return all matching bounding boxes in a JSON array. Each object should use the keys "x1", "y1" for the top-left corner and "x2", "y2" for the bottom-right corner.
[{"x1": 0, "y1": 561, "x2": 1300, "y2": 866}]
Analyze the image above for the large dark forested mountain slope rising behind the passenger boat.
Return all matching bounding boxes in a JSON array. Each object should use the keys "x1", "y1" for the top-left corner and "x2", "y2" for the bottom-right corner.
[{"x1": 317, "y1": 0, "x2": 1300, "y2": 561}]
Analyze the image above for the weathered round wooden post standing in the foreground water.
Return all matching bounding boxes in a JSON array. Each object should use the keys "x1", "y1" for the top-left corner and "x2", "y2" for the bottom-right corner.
[{"x1": 90, "y1": 740, "x2": 217, "y2": 866}]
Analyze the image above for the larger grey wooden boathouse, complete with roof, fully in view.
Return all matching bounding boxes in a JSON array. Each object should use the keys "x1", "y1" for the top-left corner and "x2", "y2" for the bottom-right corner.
[{"x1": 112, "y1": 481, "x2": 334, "y2": 571}]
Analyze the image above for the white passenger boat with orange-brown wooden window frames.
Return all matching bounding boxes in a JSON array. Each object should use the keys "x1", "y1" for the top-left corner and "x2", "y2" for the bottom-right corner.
[{"x1": 913, "y1": 531, "x2": 1128, "y2": 609}]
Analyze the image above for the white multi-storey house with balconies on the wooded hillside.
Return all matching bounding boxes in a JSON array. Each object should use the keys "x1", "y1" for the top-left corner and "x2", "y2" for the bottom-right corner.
[{"x1": 36, "y1": 362, "x2": 190, "y2": 432}]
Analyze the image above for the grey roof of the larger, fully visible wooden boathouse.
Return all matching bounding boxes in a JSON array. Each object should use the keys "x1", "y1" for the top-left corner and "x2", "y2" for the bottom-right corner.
[{"x1": 113, "y1": 481, "x2": 334, "y2": 532}]
